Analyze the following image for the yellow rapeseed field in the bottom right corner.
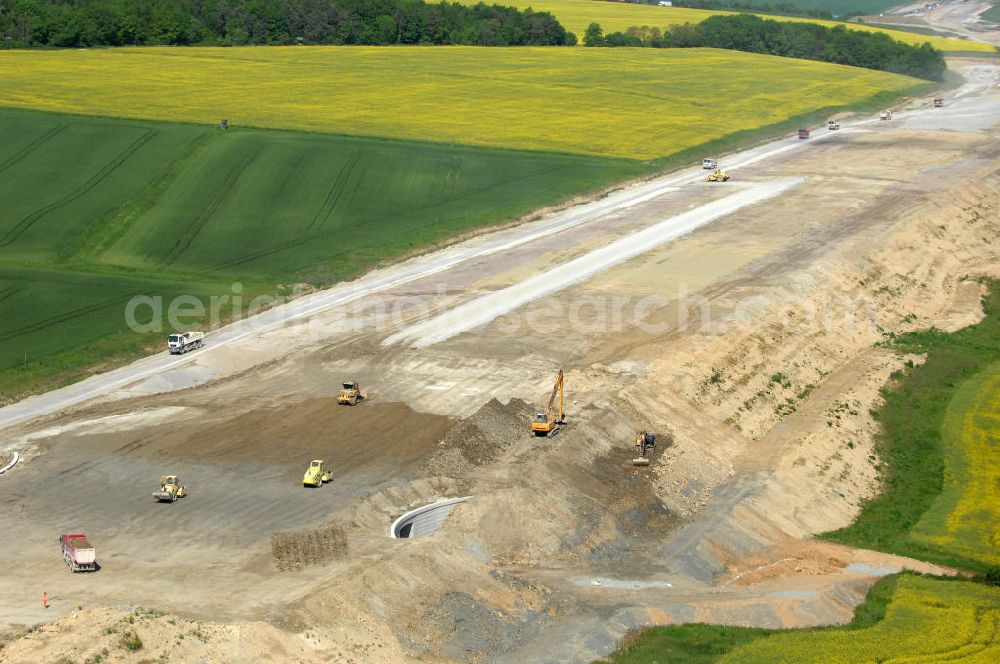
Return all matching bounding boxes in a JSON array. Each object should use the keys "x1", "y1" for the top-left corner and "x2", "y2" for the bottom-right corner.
[{"x1": 720, "y1": 576, "x2": 1000, "y2": 664}]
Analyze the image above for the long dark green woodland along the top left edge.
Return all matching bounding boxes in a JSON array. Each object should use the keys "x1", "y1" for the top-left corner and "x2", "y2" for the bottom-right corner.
[{"x1": 0, "y1": 0, "x2": 576, "y2": 48}]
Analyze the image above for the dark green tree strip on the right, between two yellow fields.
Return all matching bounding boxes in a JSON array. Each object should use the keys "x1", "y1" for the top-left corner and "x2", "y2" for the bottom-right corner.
[{"x1": 583, "y1": 14, "x2": 947, "y2": 81}]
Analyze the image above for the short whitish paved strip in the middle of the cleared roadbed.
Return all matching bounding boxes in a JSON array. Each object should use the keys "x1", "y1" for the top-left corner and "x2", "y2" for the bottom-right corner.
[{"x1": 382, "y1": 178, "x2": 803, "y2": 348}]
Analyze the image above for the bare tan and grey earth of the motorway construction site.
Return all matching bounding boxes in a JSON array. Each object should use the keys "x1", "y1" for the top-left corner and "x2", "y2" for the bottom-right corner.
[{"x1": 0, "y1": 60, "x2": 1000, "y2": 662}]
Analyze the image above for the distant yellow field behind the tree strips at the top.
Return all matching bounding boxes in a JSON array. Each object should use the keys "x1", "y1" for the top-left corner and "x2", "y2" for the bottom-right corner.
[{"x1": 478, "y1": 0, "x2": 995, "y2": 53}]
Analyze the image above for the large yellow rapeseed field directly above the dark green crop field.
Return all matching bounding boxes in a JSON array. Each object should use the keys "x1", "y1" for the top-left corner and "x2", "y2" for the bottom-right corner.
[{"x1": 0, "y1": 46, "x2": 918, "y2": 160}]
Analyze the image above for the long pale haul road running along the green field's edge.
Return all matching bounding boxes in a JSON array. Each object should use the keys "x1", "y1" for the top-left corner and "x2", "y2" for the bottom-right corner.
[{"x1": 0, "y1": 113, "x2": 884, "y2": 430}]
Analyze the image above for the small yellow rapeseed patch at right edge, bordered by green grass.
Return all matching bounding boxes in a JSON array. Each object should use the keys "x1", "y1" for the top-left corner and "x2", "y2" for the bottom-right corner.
[{"x1": 912, "y1": 364, "x2": 1000, "y2": 565}]
